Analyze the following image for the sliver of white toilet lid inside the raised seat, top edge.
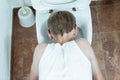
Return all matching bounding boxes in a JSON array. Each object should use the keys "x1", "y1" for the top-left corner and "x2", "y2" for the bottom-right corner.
[{"x1": 44, "y1": 0, "x2": 76, "y2": 5}]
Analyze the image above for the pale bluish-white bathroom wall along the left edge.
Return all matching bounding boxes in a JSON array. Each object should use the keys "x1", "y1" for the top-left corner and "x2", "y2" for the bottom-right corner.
[{"x1": 0, "y1": 0, "x2": 12, "y2": 80}]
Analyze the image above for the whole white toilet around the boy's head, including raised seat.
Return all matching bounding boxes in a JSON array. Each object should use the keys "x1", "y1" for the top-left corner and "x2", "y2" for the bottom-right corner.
[{"x1": 32, "y1": 0, "x2": 92, "y2": 44}]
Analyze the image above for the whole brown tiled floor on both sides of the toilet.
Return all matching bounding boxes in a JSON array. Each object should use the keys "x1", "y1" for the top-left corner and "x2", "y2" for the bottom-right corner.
[{"x1": 11, "y1": 0, "x2": 120, "y2": 80}]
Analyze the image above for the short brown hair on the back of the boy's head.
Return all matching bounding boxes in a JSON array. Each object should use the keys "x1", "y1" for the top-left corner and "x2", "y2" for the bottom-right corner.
[{"x1": 48, "y1": 11, "x2": 76, "y2": 36}]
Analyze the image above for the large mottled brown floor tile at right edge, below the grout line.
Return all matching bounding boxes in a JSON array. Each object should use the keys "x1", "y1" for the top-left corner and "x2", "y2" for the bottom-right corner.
[{"x1": 102, "y1": 32, "x2": 120, "y2": 70}]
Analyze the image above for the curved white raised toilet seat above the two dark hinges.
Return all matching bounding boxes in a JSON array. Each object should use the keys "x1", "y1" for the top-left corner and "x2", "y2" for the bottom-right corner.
[{"x1": 32, "y1": 0, "x2": 91, "y2": 11}]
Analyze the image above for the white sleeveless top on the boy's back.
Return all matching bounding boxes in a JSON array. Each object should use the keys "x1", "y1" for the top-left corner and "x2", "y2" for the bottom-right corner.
[{"x1": 39, "y1": 41, "x2": 92, "y2": 80}]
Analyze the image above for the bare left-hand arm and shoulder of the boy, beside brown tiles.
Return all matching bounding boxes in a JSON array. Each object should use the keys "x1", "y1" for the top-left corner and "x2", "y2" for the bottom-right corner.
[{"x1": 29, "y1": 43, "x2": 46, "y2": 80}]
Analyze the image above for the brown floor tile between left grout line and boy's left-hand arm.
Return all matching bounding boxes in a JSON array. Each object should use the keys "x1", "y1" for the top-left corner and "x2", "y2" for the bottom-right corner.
[{"x1": 23, "y1": 40, "x2": 37, "y2": 76}]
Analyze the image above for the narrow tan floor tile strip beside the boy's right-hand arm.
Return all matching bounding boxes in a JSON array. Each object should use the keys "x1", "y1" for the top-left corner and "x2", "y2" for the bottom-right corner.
[{"x1": 92, "y1": 33, "x2": 105, "y2": 69}]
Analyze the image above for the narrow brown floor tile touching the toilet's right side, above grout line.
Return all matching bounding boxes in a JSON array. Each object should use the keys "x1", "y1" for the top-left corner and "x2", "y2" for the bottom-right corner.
[{"x1": 91, "y1": 7, "x2": 99, "y2": 33}]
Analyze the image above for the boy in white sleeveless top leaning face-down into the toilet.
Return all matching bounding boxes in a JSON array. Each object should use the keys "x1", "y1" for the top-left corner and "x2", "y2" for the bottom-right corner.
[{"x1": 30, "y1": 11, "x2": 104, "y2": 80}]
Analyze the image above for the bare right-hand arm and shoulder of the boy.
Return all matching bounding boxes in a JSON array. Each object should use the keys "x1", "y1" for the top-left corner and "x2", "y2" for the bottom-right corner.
[{"x1": 76, "y1": 39, "x2": 105, "y2": 80}]
